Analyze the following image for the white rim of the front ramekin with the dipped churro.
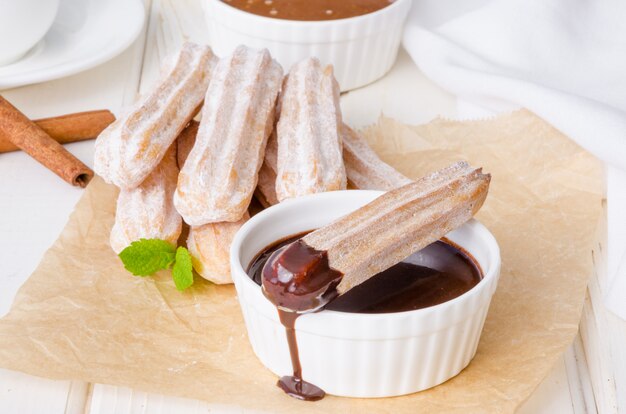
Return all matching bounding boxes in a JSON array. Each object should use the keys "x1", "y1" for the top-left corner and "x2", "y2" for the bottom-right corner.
[{"x1": 230, "y1": 190, "x2": 501, "y2": 322}]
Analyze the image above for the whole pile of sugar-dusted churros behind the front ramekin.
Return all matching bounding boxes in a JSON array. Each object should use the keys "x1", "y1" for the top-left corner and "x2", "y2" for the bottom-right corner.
[{"x1": 95, "y1": 43, "x2": 410, "y2": 283}]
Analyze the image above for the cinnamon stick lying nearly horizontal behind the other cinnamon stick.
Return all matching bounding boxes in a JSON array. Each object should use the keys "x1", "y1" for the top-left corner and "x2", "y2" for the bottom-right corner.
[{"x1": 0, "y1": 110, "x2": 115, "y2": 153}]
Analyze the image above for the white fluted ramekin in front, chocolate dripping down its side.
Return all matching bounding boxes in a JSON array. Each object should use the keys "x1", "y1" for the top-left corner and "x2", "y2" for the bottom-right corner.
[{"x1": 230, "y1": 190, "x2": 500, "y2": 397}]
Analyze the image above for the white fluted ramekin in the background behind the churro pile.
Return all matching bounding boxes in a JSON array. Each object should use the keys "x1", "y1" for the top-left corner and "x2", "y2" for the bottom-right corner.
[{"x1": 203, "y1": 0, "x2": 412, "y2": 91}]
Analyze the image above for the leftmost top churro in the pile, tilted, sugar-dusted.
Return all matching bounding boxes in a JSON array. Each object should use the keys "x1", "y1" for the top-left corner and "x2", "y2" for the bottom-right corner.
[{"x1": 94, "y1": 43, "x2": 216, "y2": 189}]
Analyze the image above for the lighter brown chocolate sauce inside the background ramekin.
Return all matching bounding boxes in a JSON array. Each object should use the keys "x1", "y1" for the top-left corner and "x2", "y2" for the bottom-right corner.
[{"x1": 222, "y1": 0, "x2": 393, "y2": 21}]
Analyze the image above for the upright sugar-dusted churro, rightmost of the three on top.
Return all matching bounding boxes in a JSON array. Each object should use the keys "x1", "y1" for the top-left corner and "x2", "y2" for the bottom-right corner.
[{"x1": 276, "y1": 58, "x2": 346, "y2": 201}]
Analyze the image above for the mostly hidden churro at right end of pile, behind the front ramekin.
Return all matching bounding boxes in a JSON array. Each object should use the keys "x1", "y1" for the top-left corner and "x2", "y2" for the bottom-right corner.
[{"x1": 342, "y1": 124, "x2": 411, "y2": 190}]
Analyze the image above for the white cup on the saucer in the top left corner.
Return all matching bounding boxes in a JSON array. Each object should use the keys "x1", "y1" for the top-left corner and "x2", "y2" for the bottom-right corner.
[{"x1": 0, "y1": 0, "x2": 59, "y2": 66}]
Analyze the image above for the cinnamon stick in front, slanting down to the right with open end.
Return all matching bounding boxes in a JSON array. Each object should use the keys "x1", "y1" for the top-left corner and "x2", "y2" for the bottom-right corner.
[{"x1": 0, "y1": 96, "x2": 93, "y2": 187}]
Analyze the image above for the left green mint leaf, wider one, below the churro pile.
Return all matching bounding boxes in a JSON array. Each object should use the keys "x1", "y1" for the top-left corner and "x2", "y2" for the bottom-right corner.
[{"x1": 119, "y1": 239, "x2": 176, "y2": 276}]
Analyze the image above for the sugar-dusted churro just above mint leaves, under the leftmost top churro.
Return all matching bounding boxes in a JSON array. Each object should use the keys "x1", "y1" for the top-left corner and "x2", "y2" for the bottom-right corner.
[{"x1": 110, "y1": 144, "x2": 182, "y2": 253}]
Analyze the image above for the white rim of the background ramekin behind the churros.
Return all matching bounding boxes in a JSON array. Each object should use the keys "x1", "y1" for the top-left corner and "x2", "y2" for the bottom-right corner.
[{"x1": 205, "y1": 0, "x2": 413, "y2": 28}]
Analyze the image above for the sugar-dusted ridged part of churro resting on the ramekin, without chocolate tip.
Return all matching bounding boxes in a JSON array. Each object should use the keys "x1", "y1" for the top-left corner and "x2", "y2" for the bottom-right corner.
[{"x1": 302, "y1": 162, "x2": 491, "y2": 294}]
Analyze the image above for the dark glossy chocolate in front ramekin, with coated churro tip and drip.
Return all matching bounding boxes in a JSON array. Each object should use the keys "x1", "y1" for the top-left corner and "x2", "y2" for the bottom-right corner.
[{"x1": 248, "y1": 232, "x2": 482, "y2": 401}]
